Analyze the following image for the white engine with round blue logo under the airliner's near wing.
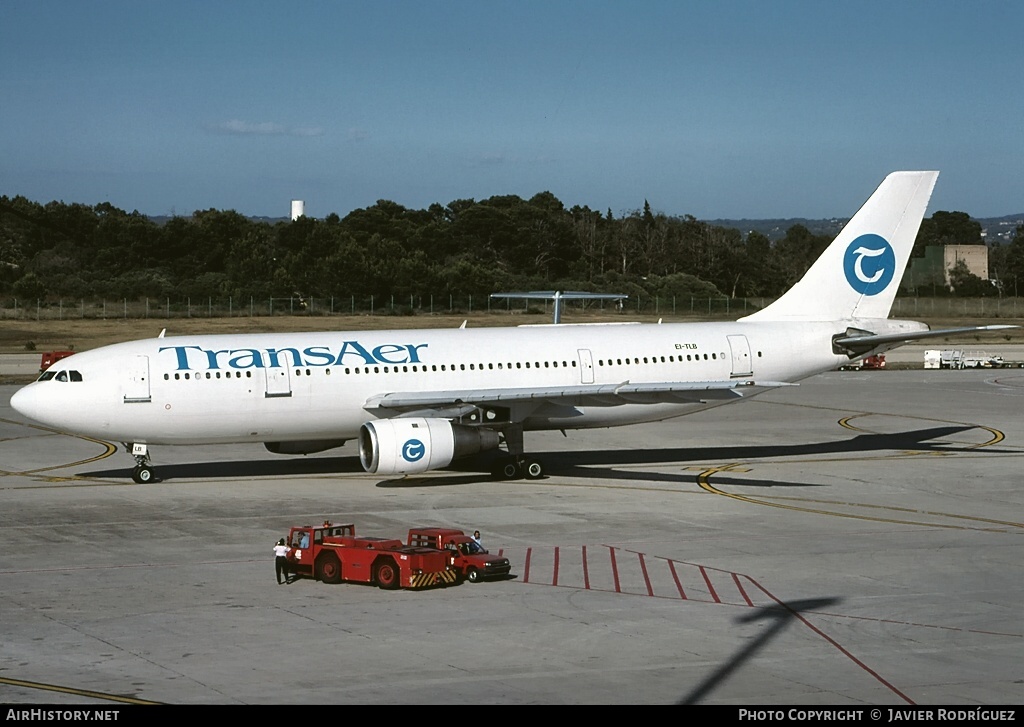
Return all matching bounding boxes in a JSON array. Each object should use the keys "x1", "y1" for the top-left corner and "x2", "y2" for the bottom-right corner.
[{"x1": 359, "y1": 417, "x2": 499, "y2": 474}]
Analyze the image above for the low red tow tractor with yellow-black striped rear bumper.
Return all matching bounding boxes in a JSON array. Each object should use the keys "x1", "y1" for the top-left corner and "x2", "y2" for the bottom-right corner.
[{"x1": 287, "y1": 522, "x2": 458, "y2": 590}]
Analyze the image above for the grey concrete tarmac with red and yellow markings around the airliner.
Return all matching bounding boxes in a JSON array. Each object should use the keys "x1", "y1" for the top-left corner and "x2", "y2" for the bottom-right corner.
[{"x1": 0, "y1": 370, "x2": 1024, "y2": 707}]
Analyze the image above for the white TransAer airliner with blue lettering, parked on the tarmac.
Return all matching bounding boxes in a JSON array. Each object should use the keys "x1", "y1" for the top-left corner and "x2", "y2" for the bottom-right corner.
[{"x1": 11, "y1": 172, "x2": 1014, "y2": 482}]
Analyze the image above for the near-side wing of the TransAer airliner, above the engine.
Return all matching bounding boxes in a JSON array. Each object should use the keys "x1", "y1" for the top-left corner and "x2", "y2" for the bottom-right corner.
[{"x1": 364, "y1": 381, "x2": 796, "y2": 412}]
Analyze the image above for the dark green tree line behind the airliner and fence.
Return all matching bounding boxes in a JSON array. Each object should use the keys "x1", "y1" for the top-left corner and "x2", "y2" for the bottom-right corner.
[{"x1": 0, "y1": 191, "x2": 1024, "y2": 301}]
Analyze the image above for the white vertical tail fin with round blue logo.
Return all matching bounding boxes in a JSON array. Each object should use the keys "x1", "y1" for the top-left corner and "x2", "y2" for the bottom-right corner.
[{"x1": 740, "y1": 172, "x2": 939, "y2": 320}]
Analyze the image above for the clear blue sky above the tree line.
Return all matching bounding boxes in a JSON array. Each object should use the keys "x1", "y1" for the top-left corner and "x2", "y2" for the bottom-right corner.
[{"x1": 0, "y1": 0, "x2": 1024, "y2": 219}]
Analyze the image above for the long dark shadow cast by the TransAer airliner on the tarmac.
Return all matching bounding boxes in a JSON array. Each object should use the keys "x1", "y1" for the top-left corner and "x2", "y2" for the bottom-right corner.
[{"x1": 79, "y1": 426, "x2": 999, "y2": 488}]
